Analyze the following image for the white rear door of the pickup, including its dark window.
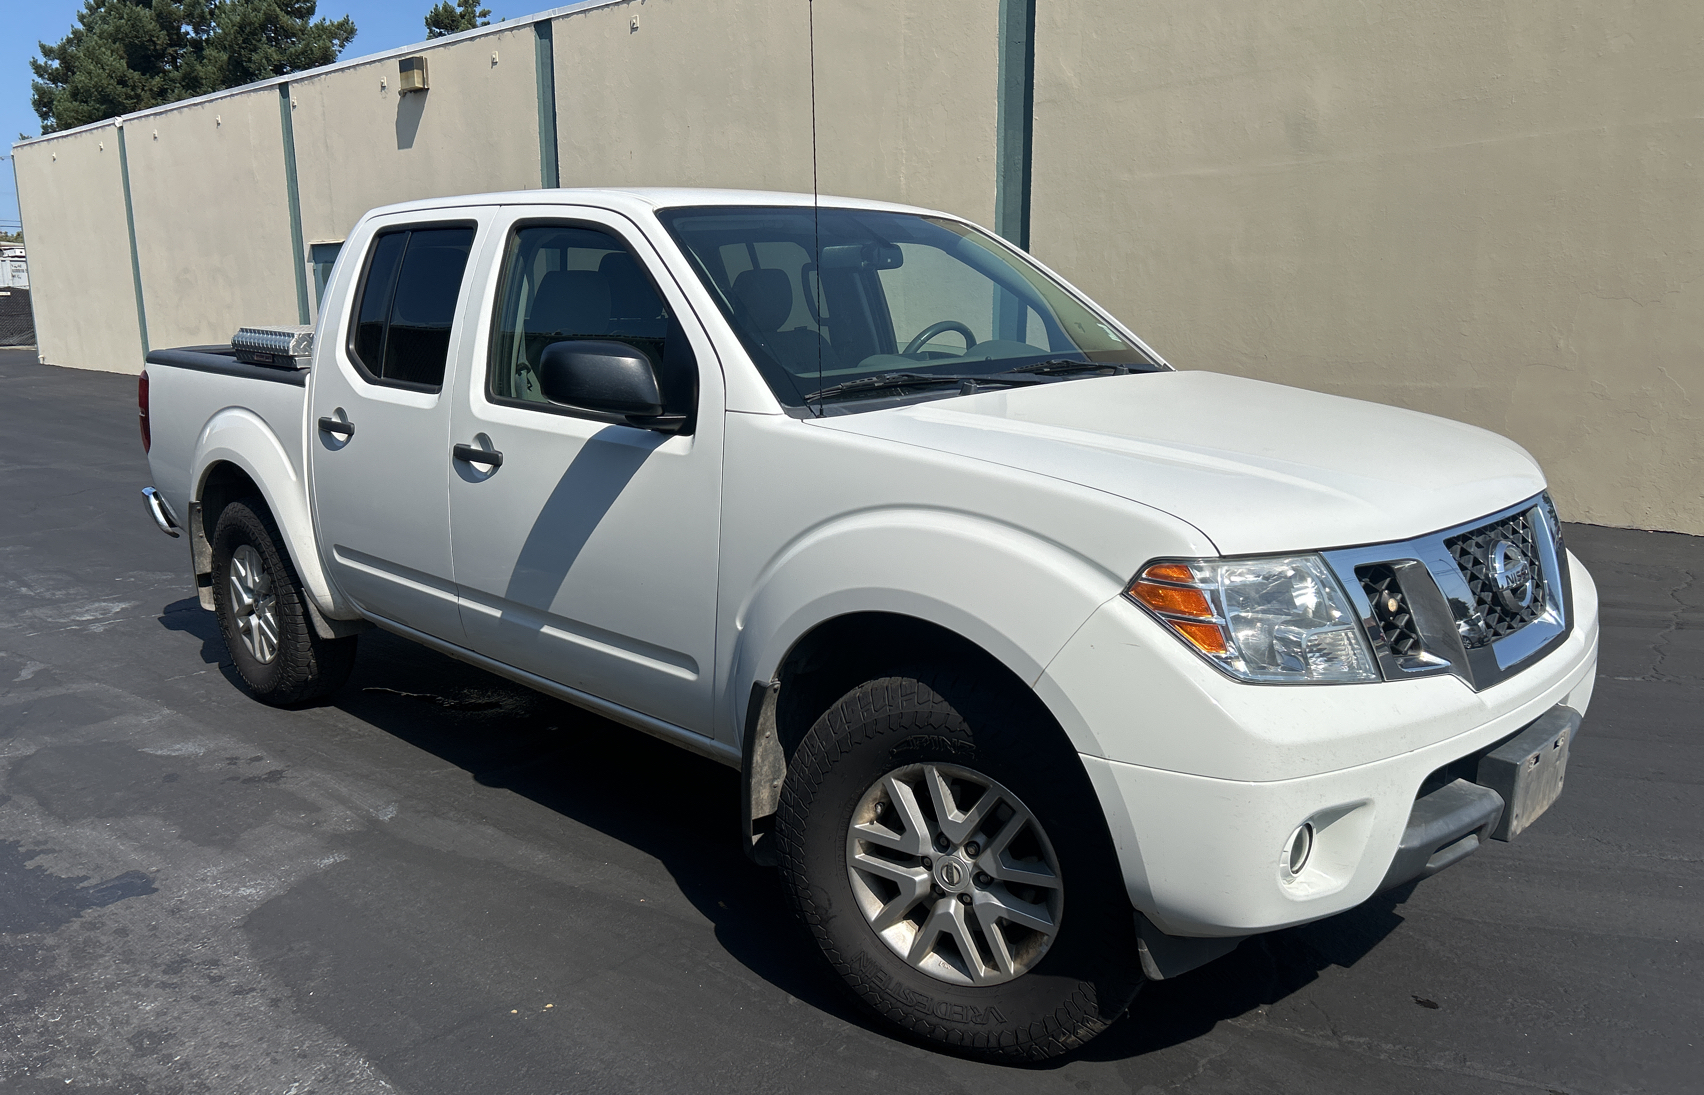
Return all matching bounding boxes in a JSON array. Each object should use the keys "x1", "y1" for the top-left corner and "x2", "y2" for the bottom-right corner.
[{"x1": 308, "y1": 209, "x2": 491, "y2": 644}]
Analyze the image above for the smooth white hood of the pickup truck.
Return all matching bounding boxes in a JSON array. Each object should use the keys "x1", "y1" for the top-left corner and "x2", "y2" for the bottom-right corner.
[{"x1": 820, "y1": 371, "x2": 1544, "y2": 555}]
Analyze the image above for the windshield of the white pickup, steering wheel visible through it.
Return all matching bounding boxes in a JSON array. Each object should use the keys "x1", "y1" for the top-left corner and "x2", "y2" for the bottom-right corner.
[{"x1": 658, "y1": 206, "x2": 1160, "y2": 409}]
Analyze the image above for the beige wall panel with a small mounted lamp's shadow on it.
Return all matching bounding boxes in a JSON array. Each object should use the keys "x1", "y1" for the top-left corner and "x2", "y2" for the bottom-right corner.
[{"x1": 291, "y1": 24, "x2": 540, "y2": 242}]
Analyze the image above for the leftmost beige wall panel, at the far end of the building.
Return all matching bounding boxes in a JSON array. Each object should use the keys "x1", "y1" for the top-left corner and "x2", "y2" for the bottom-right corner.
[{"x1": 14, "y1": 124, "x2": 141, "y2": 373}]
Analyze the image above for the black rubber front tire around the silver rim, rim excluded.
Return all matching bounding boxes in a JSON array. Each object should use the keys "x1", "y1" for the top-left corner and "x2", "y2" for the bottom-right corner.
[{"x1": 777, "y1": 668, "x2": 1143, "y2": 1063}]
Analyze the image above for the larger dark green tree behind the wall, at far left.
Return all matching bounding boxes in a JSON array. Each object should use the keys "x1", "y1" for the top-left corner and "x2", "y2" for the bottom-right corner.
[{"x1": 29, "y1": 0, "x2": 354, "y2": 133}]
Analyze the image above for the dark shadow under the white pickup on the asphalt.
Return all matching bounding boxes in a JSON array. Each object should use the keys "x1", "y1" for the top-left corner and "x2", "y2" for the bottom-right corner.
[{"x1": 299, "y1": 630, "x2": 1413, "y2": 1069}]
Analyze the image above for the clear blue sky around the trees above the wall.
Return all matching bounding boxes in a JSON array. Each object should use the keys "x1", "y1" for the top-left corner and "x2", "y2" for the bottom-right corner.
[{"x1": 0, "y1": 0, "x2": 545, "y2": 232}]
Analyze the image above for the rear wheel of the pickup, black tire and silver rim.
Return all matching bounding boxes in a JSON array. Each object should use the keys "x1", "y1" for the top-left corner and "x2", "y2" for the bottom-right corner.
[{"x1": 213, "y1": 497, "x2": 356, "y2": 705}]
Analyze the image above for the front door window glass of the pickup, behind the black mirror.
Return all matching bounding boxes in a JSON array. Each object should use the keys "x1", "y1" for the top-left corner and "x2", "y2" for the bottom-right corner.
[{"x1": 486, "y1": 225, "x2": 697, "y2": 424}]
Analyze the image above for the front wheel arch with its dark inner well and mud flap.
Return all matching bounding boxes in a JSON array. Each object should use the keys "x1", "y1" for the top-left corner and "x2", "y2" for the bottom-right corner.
[{"x1": 721, "y1": 506, "x2": 1125, "y2": 865}]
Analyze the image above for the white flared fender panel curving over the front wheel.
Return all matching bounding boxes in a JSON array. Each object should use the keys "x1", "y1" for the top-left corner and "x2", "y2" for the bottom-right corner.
[{"x1": 726, "y1": 507, "x2": 1125, "y2": 752}]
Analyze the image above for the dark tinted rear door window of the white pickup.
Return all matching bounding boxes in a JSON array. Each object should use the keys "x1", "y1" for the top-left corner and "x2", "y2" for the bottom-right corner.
[{"x1": 349, "y1": 225, "x2": 474, "y2": 392}]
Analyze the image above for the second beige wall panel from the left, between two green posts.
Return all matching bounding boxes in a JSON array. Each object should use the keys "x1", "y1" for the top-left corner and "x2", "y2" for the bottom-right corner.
[{"x1": 126, "y1": 87, "x2": 298, "y2": 346}]
